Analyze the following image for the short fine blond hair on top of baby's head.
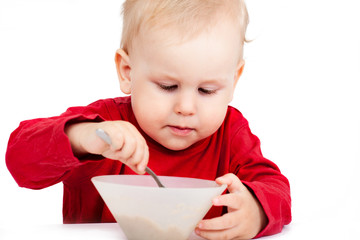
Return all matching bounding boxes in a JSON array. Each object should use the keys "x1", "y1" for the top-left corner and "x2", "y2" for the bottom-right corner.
[{"x1": 121, "y1": 0, "x2": 249, "y2": 52}]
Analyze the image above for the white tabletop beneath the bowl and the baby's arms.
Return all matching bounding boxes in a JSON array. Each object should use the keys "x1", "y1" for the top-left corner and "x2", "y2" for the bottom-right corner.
[{"x1": 0, "y1": 219, "x2": 360, "y2": 240}]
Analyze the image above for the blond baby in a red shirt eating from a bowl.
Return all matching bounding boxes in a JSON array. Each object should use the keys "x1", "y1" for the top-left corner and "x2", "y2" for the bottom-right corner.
[{"x1": 6, "y1": 0, "x2": 291, "y2": 239}]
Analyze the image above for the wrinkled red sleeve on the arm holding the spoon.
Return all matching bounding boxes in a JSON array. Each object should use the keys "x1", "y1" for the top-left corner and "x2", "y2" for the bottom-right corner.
[{"x1": 6, "y1": 100, "x2": 109, "y2": 189}]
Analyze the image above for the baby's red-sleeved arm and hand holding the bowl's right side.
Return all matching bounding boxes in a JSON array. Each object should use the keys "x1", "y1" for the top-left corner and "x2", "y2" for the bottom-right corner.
[{"x1": 198, "y1": 111, "x2": 291, "y2": 239}]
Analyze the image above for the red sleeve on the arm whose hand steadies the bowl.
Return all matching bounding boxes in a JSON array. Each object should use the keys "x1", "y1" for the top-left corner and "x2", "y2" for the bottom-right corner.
[{"x1": 231, "y1": 115, "x2": 291, "y2": 238}]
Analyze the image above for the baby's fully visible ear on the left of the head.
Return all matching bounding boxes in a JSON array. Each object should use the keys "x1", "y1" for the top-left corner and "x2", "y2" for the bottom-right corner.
[{"x1": 115, "y1": 48, "x2": 131, "y2": 94}]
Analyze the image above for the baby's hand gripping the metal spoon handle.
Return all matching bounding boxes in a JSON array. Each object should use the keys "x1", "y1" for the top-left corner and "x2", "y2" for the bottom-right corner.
[{"x1": 65, "y1": 121, "x2": 149, "y2": 174}]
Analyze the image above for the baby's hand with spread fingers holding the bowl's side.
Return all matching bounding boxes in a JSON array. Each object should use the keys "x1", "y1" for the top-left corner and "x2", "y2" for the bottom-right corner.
[{"x1": 195, "y1": 174, "x2": 267, "y2": 239}]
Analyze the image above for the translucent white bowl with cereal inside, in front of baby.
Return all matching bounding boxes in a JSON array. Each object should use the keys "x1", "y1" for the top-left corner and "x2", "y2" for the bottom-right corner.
[{"x1": 92, "y1": 175, "x2": 226, "y2": 240}]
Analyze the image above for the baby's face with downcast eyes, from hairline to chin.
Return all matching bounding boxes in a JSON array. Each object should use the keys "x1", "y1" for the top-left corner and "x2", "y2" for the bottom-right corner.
[{"x1": 120, "y1": 19, "x2": 243, "y2": 150}]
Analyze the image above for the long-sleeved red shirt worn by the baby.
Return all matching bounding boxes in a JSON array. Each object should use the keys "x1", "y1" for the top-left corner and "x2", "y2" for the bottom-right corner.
[{"x1": 6, "y1": 97, "x2": 291, "y2": 237}]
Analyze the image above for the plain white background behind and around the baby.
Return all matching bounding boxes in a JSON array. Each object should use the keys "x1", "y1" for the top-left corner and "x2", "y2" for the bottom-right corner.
[{"x1": 0, "y1": 0, "x2": 360, "y2": 239}]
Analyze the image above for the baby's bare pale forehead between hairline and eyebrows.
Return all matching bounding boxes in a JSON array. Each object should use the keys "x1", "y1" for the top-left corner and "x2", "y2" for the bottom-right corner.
[{"x1": 129, "y1": 19, "x2": 241, "y2": 76}]
